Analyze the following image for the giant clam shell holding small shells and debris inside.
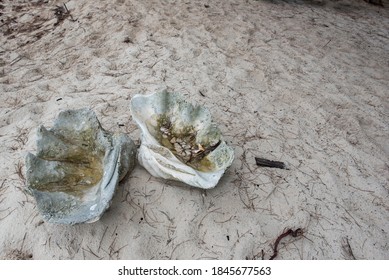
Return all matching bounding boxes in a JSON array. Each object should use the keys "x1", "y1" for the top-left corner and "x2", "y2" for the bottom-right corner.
[{"x1": 131, "y1": 91, "x2": 234, "y2": 189}]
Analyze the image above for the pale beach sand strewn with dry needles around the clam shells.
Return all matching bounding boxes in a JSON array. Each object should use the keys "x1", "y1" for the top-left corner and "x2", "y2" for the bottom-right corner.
[{"x1": 0, "y1": 0, "x2": 389, "y2": 260}]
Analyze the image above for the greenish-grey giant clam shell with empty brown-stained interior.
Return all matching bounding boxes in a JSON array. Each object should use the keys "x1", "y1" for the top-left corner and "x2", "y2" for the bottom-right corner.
[{"x1": 26, "y1": 109, "x2": 136, "y2": 224}]
